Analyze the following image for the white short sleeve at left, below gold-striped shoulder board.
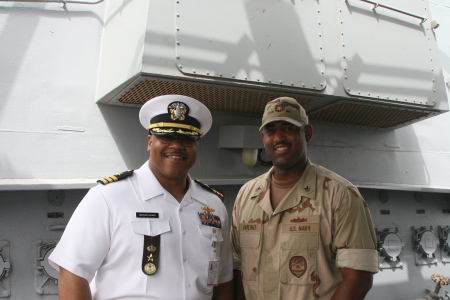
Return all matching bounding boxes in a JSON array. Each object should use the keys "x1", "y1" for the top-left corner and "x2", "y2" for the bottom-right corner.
[{"x1": 49, "y1": 186, "x2": 111, "y2": 282}]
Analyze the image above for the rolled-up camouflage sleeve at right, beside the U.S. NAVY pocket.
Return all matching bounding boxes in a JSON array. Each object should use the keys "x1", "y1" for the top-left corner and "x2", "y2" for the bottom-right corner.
[{"x1": 332, "y1": 187, "x2": 378, "y2": 273}]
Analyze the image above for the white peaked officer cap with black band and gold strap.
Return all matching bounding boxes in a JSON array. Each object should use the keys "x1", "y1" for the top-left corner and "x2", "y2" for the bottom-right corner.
[{"x1": 139, "y1": 95, "x2": 212, "y2": 137}]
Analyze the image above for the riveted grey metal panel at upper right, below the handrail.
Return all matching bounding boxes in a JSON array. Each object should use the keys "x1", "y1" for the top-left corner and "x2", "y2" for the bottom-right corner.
[{"x1": 338, "y1": 0, "x2": 445, "y2": 107}]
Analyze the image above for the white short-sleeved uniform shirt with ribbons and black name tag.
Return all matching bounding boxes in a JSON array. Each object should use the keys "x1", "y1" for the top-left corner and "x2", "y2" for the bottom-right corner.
[{"x1": 49, "y1": 162, "x2": 233, "y2": 300}]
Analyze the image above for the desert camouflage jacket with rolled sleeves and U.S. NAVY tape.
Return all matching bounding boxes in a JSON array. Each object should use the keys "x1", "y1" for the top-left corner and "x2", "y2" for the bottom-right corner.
[{"x1": 231, "y1": 160, "x2": 378, "y2": 300}]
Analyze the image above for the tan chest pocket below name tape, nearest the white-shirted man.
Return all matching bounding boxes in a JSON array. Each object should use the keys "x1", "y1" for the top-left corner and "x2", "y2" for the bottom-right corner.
[{"x1": 239, "y1": 224, "x2": 261, "y2": 281}]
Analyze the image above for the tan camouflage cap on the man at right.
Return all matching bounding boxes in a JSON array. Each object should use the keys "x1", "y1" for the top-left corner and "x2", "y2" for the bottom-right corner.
[{"x1": 259, "y1": 97, "x2": 309, "y2": 130}]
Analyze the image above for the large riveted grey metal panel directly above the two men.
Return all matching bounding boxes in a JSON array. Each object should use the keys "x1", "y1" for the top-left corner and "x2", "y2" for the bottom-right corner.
[{"x1": 175, "y1": 0, "x2": 326, "y2": 90}]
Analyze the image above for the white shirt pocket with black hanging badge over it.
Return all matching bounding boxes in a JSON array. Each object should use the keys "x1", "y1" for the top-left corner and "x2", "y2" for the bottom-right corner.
[{"x1": 131, "y1": 220, "x2": 172, "y2": 266}]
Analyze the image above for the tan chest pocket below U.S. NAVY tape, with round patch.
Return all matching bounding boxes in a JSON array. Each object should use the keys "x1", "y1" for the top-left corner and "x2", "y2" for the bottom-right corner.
[{"x1": 280, "y1": 220, "x2": 319, "y2": 285}]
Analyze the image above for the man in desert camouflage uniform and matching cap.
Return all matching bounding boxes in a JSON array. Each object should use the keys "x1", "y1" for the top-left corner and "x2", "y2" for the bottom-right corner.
[{"x1": 231, "y1": 97, "x2": 378, "y2": 300}]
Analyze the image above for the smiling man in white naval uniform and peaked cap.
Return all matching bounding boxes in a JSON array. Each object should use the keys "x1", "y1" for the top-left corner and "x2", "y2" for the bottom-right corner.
[{"x1": 49, "y1": 95, "x2": 233, "y2": 300}]
